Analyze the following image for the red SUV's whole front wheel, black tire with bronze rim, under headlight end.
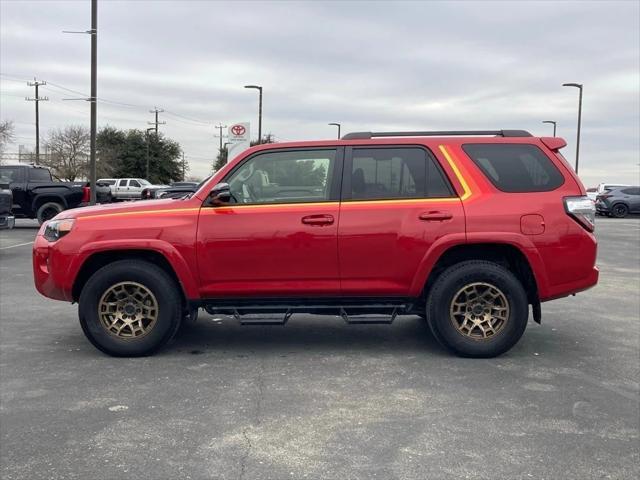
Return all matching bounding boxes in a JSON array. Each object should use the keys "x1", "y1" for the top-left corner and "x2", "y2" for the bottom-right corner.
[{"x1": 78, "y1": 260, "x2": 182, "y2": 357}]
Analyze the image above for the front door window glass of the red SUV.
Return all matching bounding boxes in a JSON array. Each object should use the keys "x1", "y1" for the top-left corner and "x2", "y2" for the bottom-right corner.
[{"x1": 224, "y1": 149, "x2": 336, "y2": 204}]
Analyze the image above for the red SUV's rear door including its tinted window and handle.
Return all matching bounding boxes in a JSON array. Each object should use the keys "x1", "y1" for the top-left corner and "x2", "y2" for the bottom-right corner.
[{"x1": 338, "y1": 146, "x2": 465, "y2": 297}]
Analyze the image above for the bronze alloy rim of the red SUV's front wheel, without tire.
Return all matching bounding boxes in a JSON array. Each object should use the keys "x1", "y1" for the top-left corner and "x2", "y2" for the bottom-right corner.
[{"x1": 98, "y1": 282, "x2": 158, "y2": 340}]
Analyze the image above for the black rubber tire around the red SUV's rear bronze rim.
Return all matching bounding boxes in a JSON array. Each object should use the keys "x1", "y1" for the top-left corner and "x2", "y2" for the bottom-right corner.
[{"x1": 426, "y1": 260, "x2": 529, "y2": 358}]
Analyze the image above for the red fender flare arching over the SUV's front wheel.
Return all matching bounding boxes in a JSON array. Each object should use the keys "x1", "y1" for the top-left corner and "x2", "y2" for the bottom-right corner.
[{"x1": 68, "y1": 239, "x2": 199, "y2": 300}]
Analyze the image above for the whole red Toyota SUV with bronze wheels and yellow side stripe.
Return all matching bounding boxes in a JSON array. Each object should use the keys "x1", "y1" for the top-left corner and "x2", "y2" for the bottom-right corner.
[{"x1": 33, "y1": 130, "x2": 598, "y2": 357}]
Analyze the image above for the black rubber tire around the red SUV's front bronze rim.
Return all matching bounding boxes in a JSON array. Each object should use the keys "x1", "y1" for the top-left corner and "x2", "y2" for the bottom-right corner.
[{"x1": 78, "y1": 260, "x2": 183, "y2": 357}]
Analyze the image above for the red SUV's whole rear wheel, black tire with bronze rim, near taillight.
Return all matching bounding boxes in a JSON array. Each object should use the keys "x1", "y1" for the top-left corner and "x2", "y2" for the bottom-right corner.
[{"x1": 426, "y1": 260, "x2": 529, "y2": 358}]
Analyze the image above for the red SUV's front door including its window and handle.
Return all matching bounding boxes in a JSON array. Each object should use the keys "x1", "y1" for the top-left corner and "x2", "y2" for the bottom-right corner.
[{"x1": 197, "y1": 148, "x2": 343, "y2": 298}]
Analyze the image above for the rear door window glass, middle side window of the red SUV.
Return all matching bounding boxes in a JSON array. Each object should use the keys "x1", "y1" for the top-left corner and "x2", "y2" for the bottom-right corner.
[{"x1": 345, "y1": 147, "x2": 453, "y2": 200}]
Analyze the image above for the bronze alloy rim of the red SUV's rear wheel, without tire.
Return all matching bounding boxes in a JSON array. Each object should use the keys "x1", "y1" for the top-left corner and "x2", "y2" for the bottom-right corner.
[{"x1": 450, "y1": 282, "x2": 509, "y2": 340}]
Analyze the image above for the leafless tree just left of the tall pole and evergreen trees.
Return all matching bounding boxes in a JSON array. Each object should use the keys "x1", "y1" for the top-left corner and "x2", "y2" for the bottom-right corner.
[{"x1": 40, "y1": 125, "x2": 90, "y2": 182}]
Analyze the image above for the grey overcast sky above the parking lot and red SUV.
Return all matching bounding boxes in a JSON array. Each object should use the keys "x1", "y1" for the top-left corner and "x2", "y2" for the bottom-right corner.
[{"x1": 0, "y1": 0, "x2": 640, "y2": 186}]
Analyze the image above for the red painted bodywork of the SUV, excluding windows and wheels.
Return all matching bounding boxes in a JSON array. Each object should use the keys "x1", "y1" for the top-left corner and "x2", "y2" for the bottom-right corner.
[{"x1": 33, "y1": 137, "x2": 598, "y2": 300}]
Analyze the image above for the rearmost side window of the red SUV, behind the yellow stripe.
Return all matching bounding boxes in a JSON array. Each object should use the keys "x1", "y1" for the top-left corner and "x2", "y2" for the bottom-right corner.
[{"x1": 462, "y1": 143, "x2": 564, "y2": 192}]
